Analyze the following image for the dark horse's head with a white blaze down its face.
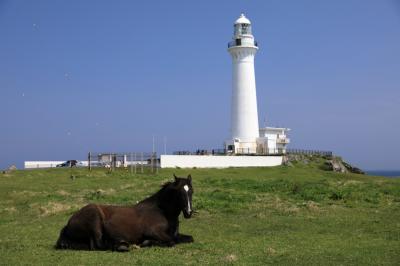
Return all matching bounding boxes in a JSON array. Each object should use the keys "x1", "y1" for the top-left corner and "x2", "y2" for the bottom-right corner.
[{"x1": 174, "y1": 174, "x2": 193, "y2": 219}]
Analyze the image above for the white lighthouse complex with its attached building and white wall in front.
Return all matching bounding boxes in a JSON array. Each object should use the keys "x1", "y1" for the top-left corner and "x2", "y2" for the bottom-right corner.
[{"x1": 160, "y1": 14, "x2": 290, "y2": 168}]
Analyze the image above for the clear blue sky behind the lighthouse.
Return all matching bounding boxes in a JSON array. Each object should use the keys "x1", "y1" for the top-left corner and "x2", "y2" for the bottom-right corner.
[{"x1": 0, "y1": 0, "x2": 400, "y2": 169}]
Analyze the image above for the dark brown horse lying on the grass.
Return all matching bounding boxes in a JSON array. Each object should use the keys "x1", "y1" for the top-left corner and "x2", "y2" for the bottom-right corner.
[{"x1": 55, "y1": 175, "x2": 193, "y2": 251}]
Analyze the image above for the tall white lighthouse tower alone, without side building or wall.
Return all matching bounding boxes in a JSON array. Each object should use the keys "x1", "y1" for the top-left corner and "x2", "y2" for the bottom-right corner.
[{"x1": 226, "y1": 14, "x2": 260, "y2": 154}]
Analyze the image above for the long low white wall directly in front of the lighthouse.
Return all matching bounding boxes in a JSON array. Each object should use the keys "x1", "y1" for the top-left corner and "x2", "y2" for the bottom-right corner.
[{"x1": 161, "y1": 155, "x2": 282, "y2": 168}]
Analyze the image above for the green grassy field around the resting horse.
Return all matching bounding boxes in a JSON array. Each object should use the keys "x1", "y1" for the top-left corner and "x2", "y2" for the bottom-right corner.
[{"x1": 0, "y1": 162, "x2": 400, "y2": 265}]
